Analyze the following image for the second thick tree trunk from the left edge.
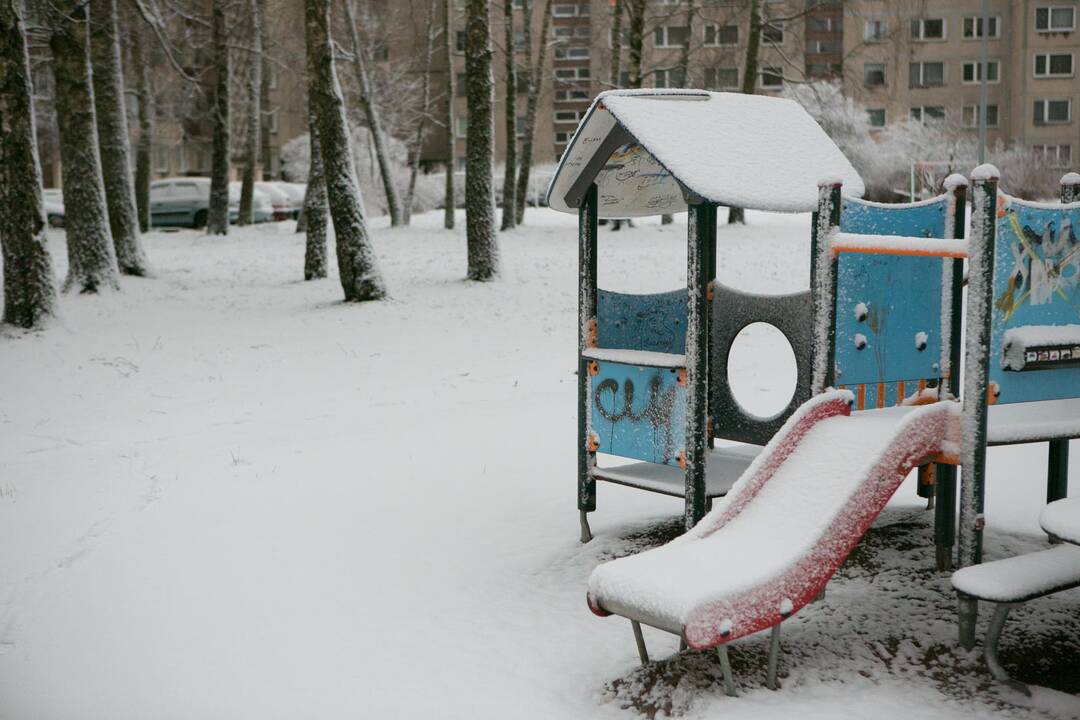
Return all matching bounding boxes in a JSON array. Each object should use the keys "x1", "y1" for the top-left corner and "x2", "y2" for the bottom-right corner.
[{"x1": 49, "y1": 0, "x2": 120, "y2": 293}]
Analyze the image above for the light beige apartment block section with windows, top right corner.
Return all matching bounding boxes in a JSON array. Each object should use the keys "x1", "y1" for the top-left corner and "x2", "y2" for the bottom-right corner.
[{"x1": 843, "y1": 0, "x2": 1080, "y2": 168}]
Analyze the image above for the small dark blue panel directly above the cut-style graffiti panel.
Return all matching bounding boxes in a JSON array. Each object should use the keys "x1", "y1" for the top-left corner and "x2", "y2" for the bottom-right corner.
[{"x1": 596, "y1": 290, "x2": 686, "y2": 355}]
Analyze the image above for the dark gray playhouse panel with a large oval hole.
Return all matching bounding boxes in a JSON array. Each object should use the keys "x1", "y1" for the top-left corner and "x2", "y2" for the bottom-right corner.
[{"x1": 708, "y1": 282, "x2": 813, "y2": 445}]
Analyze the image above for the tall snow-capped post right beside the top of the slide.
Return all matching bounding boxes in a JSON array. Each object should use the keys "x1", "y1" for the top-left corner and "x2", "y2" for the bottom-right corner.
[{"x1": 959, "y1": 165, "x2": 1000, "y2": 647}]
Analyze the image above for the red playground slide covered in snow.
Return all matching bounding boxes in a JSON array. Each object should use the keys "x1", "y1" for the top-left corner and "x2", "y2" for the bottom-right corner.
[{"x1": 589, "y1": 391, "x2": 959, "y2": 649}]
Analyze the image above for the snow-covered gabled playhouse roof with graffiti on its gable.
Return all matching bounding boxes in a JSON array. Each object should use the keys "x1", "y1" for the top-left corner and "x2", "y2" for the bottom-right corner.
[{"x1": 548, "y1": 90, "x2": 864, "y2": 217}]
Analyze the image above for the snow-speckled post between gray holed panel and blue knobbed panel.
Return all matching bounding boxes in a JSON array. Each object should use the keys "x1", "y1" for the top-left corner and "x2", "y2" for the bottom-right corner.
[{"x1": 810, "y1": 180, "x2": 841, "y2": 395}]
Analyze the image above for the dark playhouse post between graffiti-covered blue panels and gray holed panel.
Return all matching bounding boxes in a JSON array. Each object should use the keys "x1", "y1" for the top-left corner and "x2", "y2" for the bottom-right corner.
[{"x1": 685, "y1": 202, "x2": 716, "y2": 530}]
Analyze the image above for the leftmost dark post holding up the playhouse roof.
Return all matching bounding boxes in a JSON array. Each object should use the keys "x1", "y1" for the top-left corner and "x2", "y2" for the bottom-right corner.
[{"x1": 578, "y1": 182, "x2": 598, "y2": 543}]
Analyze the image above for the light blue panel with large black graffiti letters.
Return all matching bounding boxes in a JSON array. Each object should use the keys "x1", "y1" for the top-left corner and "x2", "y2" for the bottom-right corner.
[{"x1": 590, "y1": 362, "x2": 686, "y2": 466}]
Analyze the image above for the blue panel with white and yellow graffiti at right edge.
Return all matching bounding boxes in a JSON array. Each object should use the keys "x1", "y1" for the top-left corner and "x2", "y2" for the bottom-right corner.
[{"x1": 990, "y1": 195, "x2": 1080, "y2": 403}]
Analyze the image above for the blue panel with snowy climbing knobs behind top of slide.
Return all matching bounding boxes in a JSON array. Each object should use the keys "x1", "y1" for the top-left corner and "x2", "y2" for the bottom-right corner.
[{"x1": 836, "y1": 196, "x2": 948, "y2": 388}]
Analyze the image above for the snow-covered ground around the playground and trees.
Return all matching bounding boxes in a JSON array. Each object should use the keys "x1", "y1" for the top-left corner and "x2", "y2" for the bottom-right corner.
[{"x1": 0, "y1": 210, "x2": 1080, "y2": 720}]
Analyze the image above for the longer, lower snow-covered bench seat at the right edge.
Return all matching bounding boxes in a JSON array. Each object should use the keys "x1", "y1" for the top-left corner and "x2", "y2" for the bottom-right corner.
[{"x1": 953, "y1": 544, "x2": 1080, "y2": 602}]
